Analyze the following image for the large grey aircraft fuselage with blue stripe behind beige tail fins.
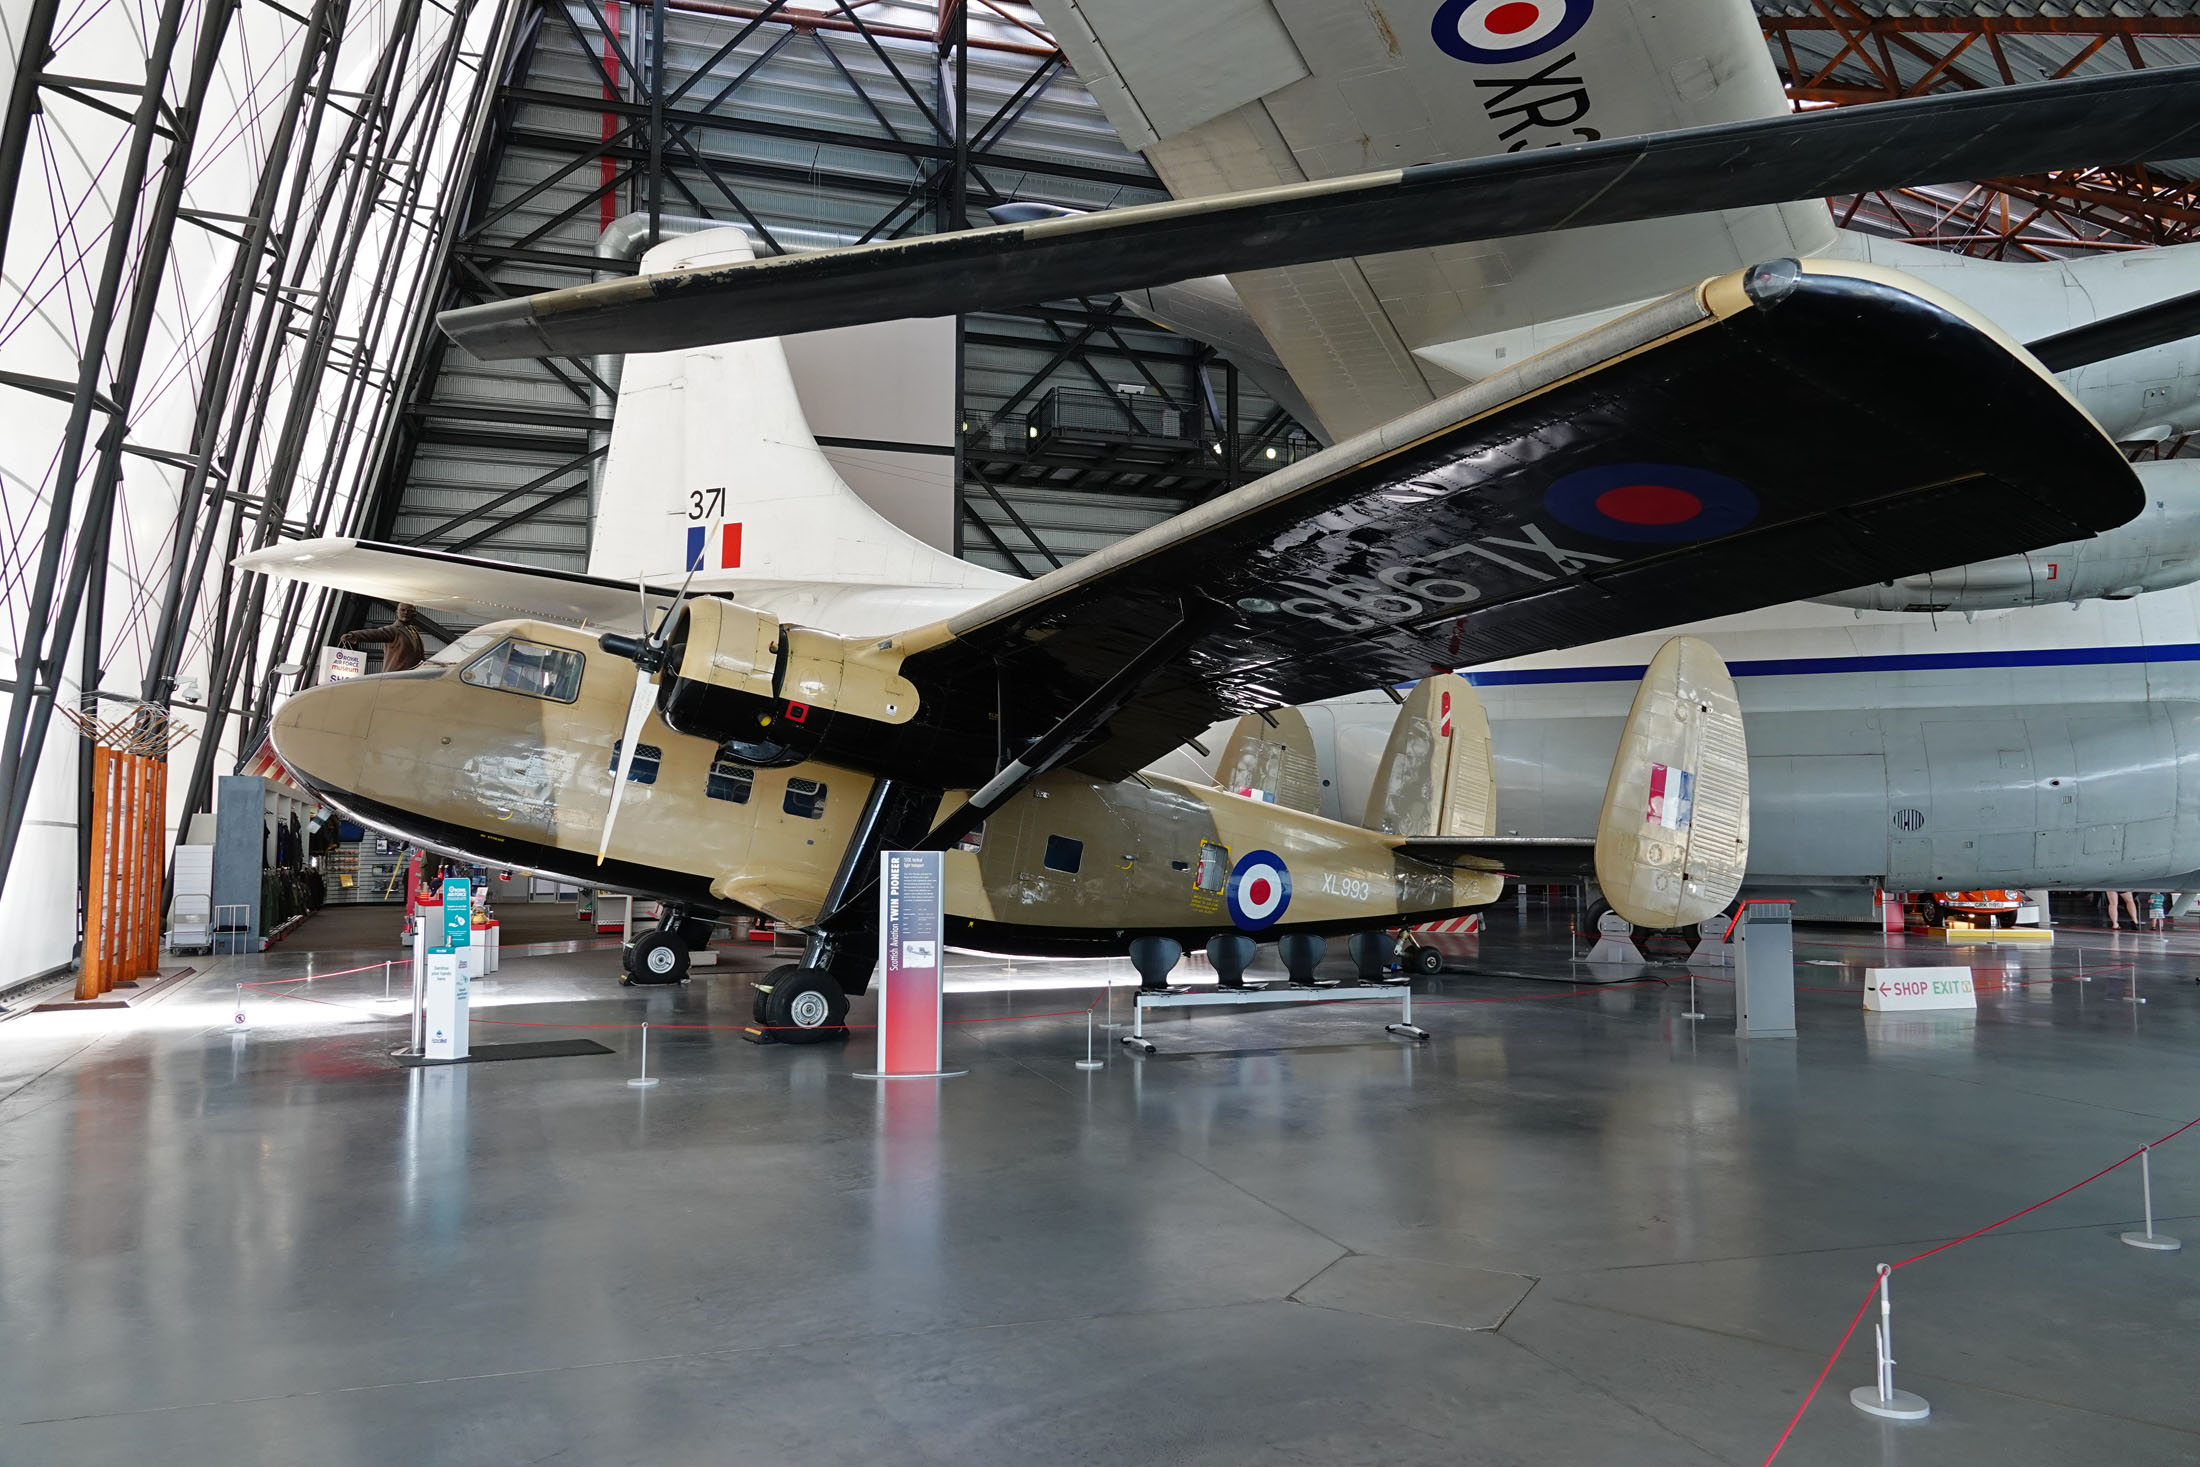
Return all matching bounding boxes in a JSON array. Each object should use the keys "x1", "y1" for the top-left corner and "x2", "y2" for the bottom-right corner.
[{"x1": 1267, "y1": 587, "x2": 2200, "y2": 915}]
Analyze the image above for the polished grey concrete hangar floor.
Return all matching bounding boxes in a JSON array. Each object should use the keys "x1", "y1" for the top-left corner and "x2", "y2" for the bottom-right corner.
[{"x1": 0, "y1": 908, "x2": 2200, "y2": 1467}]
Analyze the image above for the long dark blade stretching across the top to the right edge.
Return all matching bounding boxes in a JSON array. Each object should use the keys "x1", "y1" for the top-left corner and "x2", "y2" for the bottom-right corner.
[{"x1": 438, "y1": 66, "x2": 2200, "y2": 361}]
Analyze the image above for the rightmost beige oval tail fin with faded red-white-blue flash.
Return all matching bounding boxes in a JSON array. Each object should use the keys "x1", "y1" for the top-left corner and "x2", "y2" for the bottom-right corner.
[{"x1": 1597, "y1": 636, "x2": 1749, "y2": 928}]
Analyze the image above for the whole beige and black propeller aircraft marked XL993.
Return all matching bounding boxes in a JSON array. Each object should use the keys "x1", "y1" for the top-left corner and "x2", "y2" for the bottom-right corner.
[{"x1": 266, "y1": 260, "x2": 2141, "y2": 1038}]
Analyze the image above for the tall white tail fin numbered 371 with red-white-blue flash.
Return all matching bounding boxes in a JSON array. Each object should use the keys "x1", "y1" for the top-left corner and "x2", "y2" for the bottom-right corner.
[{"x1": 590, "y1": 229, "x2": 1008, "y2": 589}]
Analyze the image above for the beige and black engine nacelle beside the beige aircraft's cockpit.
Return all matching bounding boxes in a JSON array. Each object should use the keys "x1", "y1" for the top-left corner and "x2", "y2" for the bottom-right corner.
[{"x1": 658, "y1": 596, "x2": 917, "y2": 768}]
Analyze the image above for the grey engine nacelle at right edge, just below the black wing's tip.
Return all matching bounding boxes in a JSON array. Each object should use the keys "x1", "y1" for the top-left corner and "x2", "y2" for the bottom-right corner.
[{"x1": 1817, "y1": 457, "x2": 2200, "y2": 611}]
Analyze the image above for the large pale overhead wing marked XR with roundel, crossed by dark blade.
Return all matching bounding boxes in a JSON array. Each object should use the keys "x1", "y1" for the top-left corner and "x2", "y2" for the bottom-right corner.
[{"x1": 1036, "y1": 0, "x2": 1835, "y2": 435}]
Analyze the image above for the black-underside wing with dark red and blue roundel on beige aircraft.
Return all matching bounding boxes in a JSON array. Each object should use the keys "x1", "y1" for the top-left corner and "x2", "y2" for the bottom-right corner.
[{"x1": 902, "y1": 262, "x2": 2143, "y2": 779}]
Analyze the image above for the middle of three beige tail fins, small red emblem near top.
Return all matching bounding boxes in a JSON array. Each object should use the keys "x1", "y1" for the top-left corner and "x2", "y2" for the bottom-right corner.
[{"x1": 1362, "y1": 673, "x2": 1498, "y2": 836}]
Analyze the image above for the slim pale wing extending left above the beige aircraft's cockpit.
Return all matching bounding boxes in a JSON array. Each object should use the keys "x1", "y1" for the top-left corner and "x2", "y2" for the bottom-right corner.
[{"x1": 235, "y1": 537, "x2": 680, "y2": 631}]
